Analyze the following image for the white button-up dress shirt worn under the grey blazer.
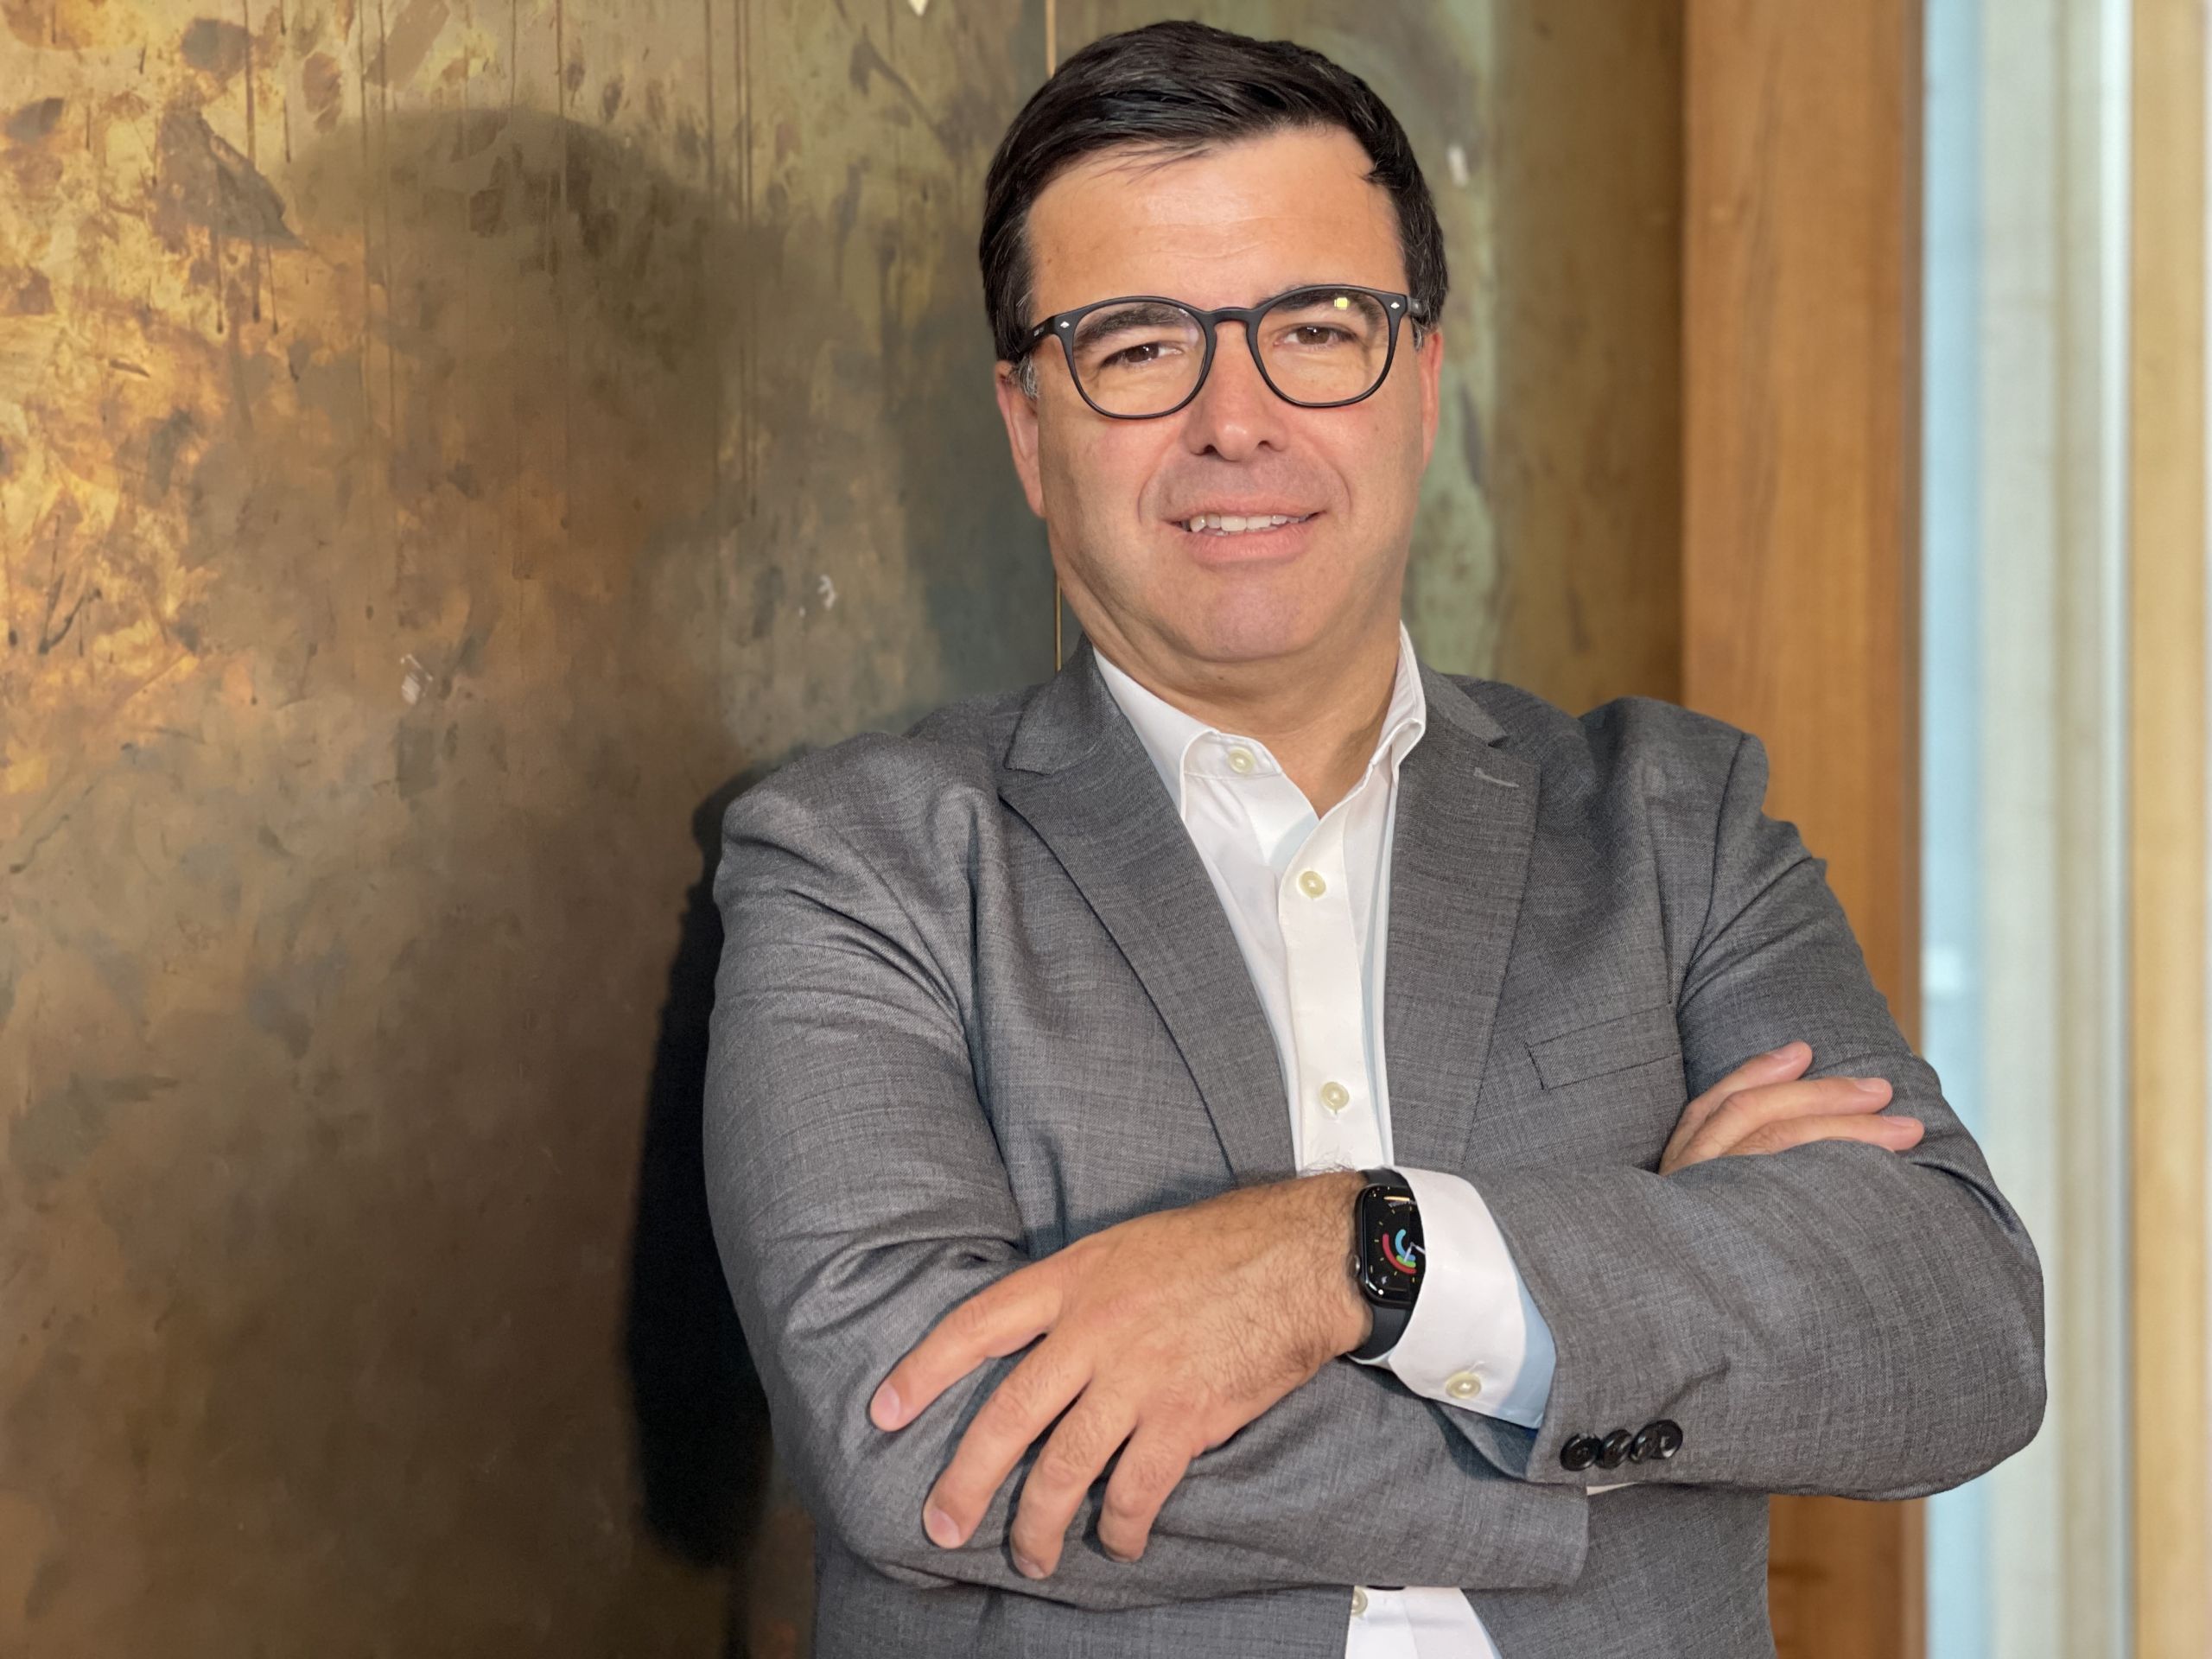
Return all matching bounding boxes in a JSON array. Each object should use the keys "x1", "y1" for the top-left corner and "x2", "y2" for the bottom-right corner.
[{"x1": 1095, "y1": 624, "x2": 1555, "y2": 1659}]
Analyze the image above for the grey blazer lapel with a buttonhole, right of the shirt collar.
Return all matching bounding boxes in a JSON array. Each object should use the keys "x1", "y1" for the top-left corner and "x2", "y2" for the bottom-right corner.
[{"x1": 1382, "y1": 666, "x2": 1537, "y2": 1174}]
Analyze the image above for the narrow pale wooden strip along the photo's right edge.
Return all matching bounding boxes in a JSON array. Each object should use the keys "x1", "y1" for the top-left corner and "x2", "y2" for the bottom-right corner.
[{"x1": 2128, "y1": 0, "x2": 2212, "y2": 1659}]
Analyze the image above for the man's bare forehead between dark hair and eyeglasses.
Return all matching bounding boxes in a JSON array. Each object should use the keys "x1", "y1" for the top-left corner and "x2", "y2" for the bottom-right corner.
[{"x1": 1028, "y1": 128, "x2": 1405, "y2": 319}]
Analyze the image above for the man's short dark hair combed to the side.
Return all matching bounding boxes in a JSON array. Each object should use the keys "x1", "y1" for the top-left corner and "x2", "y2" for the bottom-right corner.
[{"x1": 978, "y1": 22, "x2": 1449, "y2": 390}]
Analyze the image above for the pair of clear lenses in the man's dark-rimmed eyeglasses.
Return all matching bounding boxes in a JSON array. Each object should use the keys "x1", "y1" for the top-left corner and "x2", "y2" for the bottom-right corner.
[{"x1": 1068, "y1": 288, "x2": 1389, "y2": 416}]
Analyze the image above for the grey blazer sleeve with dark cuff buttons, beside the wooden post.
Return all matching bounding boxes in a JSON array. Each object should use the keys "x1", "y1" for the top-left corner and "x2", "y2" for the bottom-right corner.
[{"x1": 1455, "y1": 723, "x2": 2044, "y2": 1497}]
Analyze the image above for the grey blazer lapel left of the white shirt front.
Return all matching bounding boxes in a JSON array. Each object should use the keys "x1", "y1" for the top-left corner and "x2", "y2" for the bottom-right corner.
[{"x1": 1000, "y1": 639, "x2": 1300, "y2": 1181}]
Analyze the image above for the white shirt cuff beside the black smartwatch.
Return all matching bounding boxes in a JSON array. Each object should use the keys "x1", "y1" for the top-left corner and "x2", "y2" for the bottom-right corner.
[{"x1": 1378, "y1": 1166, "x2": 1557, "y2": 1429}]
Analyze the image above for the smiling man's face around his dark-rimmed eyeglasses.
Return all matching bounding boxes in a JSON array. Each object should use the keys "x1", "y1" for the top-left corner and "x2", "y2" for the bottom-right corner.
[{"x1": 998, "y1": 128, "x2": 1442, "y2": 683}]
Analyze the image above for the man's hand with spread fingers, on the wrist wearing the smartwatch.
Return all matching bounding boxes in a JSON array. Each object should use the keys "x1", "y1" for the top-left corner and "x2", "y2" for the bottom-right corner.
[{"x1": 869, "y1": 1173, "x2": 1371, "y2": 1580}]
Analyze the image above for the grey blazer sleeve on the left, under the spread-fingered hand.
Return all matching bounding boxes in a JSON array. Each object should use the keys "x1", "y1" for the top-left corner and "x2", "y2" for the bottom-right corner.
[{"x1": 703, "y1": 760, "x2": 1588, "y2": 1608}]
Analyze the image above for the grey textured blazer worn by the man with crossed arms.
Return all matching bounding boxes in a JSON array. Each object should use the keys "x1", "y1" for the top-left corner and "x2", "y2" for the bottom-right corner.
[{"x1": 706, "y1": 646, "x2": 2044, "y2": 1659}]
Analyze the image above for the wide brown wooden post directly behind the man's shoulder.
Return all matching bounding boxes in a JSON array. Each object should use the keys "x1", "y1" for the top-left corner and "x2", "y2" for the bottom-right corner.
[{"x1": 1683, "y1": 0, "x2": 1923, "y2": 1659}]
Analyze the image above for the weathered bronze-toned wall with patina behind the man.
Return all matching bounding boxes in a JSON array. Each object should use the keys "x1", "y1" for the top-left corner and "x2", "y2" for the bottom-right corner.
[{"x1": 0, "y1": 0, "x2": 1663, "y2": 1659}]
